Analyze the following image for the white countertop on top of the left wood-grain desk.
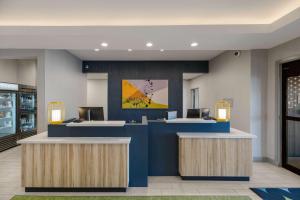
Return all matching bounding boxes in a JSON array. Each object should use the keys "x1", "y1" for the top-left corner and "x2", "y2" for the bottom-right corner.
[{"x1": 17, "y1": 132, "x2": 131, "y2": 144}]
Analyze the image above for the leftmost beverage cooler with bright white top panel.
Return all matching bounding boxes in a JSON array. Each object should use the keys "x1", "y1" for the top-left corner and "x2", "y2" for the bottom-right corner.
[{"x1": 0, "y1": 83, "x2": 18, "y2": 151}]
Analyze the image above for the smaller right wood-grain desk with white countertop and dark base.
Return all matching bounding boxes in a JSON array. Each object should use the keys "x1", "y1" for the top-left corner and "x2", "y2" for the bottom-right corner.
[{"x1": 177, "y1": 129, "x2": 255, "y2": 181}]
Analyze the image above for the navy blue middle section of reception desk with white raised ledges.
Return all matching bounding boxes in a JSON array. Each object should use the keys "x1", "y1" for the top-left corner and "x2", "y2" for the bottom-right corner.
[{"x1": 21, "y1": 119, "x2": 246, "y2": 191}]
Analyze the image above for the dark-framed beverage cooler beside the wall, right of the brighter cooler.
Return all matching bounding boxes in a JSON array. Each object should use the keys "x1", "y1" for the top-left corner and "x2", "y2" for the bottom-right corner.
[{"x1": 18, "y1": 85, "x2": 37, "y2": 139}]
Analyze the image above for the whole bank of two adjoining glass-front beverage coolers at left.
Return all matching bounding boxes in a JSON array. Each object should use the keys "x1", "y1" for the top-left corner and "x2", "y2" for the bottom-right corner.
[{"x1": 0, "y1": 83, "x2": 37, "y2": 152}]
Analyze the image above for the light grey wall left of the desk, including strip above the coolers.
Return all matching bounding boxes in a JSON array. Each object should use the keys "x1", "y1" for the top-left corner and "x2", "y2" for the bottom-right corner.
[{"x1": 0, "y1": 49, "x2": 86, "y2": 133}]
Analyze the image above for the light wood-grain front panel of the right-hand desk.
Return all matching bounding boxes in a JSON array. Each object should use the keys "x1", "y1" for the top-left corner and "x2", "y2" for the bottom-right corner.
[{"x1": 179, "y1": 138, "x2": 252, "y2": 176}]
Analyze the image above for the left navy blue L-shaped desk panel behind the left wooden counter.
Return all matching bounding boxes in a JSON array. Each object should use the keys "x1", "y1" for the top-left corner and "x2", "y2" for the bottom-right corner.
[{"x1": 48, "y1": 124, "x2": 148, "y2": 187}]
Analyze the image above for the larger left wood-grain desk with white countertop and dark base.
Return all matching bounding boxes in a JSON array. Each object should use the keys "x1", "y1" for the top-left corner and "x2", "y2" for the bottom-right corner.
[{"x1": 19, "y1": 132, "x2": 131, "y2": 191}]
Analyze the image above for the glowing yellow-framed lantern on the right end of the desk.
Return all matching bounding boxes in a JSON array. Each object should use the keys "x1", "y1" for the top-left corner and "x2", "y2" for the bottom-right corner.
[{"x1": 215, "y1": 100, "x2": 231, "y2": 122}]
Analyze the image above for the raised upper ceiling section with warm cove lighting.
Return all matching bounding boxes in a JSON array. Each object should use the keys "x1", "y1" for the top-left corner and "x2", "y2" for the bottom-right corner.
[{"x1": 0, "y1": 0, "x2": 300, "y2": 26}]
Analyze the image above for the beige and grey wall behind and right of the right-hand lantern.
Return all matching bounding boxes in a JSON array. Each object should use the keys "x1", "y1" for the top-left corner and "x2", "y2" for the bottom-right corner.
[{"x1": 190, "y1": 50, "x2": 267, "y2": 160}]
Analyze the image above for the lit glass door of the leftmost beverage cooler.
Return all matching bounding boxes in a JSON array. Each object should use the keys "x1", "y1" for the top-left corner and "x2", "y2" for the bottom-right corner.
[{"x1": 0, "y1": 91, "x2": 16, "y2": 137}]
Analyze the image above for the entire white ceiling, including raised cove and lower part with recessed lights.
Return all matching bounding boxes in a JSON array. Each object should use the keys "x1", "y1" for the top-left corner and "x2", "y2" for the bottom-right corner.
[{"x1": 0, "y1": 0, "x2": 300, "y2": 60}]
